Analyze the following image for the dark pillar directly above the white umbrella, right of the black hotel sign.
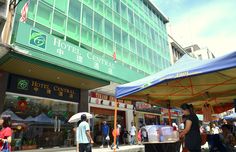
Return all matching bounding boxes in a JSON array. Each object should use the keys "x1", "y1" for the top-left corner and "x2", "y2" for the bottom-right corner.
[{"x1": 78, "y1": 89, "x2": 89, "y2": 112}]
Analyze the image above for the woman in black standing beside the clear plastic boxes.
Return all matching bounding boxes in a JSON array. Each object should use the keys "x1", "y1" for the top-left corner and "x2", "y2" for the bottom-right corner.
[{"x1": 180, "y1": 104, "x2": 201, "y2": 152}]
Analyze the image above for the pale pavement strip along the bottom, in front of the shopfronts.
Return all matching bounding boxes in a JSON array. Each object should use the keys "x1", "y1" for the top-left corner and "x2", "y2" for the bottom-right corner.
[{"x1": 18, "y1": 145, "x2": 144, "y2": 152}]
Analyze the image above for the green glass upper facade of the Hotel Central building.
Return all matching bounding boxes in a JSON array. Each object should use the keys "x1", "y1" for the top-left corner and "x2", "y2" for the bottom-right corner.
[{"x1": 12, "y1": 0, "x2": 170, "y2": 83}]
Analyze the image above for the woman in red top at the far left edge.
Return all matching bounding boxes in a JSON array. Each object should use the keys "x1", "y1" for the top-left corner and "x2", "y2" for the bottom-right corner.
[{"x1": 0, "y1": 115, "x2": 12, "y2": 152}]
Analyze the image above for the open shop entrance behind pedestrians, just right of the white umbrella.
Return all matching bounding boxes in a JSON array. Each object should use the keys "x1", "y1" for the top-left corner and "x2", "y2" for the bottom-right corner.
[{"x1": 90, "y1": 107, "x2": 126, "y2": 144}]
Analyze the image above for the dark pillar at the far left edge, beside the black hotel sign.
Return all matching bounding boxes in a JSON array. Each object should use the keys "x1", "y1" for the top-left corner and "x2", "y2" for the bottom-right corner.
[{"x1": 0, "y1": 71, "x2": 9, "y2": 114}]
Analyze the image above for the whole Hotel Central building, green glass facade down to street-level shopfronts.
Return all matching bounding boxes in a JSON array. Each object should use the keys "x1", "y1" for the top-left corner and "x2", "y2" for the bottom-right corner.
[{"x1": 0, "y1": 0, "x2": 171, "y2": 150}]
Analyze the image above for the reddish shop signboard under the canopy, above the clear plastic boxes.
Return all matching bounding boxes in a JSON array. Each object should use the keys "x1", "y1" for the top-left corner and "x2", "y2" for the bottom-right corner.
[{"x1": 135, "y1": 102, "x2": 161, "y2": 114}]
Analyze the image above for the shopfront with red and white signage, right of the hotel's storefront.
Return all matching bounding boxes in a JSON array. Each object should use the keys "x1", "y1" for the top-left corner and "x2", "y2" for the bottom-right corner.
[{"x1": 89, "y1": 92, "x2": 133, "y2": 144}]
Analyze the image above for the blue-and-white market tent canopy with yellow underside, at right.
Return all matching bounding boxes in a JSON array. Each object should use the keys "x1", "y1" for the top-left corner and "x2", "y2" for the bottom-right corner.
[{"x1": 116, "y1": 52, "x2": 236, "y2": 108}]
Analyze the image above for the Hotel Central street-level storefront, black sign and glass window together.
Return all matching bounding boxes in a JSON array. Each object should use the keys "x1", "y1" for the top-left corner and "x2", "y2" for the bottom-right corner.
[{"x1": 0, "y1": 74, "x2": 81, "y2": 150}]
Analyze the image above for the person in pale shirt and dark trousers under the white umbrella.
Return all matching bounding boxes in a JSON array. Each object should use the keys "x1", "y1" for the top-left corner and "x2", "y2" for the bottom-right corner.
[{"x1": 78, "y1": 114, "x2": 94, "y2": 152}]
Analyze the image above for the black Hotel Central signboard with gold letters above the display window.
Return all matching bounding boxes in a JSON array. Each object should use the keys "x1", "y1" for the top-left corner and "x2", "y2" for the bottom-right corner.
[{"x1": 7, "y1": 74, "x2": 80, "y2": 103}]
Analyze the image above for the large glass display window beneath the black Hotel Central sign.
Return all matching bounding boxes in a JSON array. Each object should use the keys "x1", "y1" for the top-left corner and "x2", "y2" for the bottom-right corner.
[{"x1": 2, "y1": 93, "x2": 78, "y2": 150}]
